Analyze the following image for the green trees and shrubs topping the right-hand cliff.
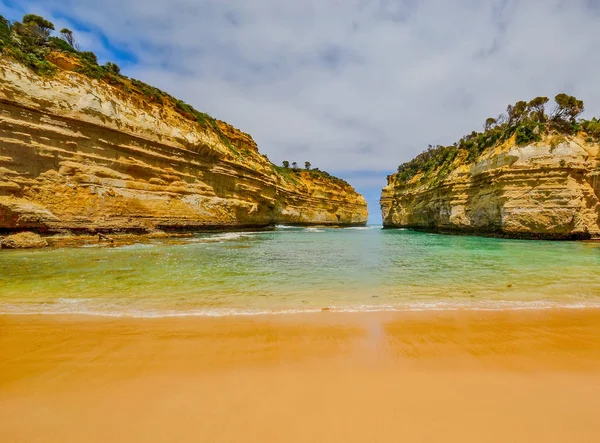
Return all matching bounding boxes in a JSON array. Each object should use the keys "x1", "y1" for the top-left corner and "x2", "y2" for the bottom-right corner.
[{"x1": 396, "y1": 94, "x2": 600, "y2": 185}]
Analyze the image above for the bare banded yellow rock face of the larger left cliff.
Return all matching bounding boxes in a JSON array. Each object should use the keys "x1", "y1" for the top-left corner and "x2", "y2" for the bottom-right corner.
[{"x1": 0, "y1": 59, "x2": 367, "y2": 232}]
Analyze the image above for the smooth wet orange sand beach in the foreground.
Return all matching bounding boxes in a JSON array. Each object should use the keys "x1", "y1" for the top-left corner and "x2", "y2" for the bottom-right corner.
[{"x1": 0, "y1": 309, "x2": 600, "y2": 442}]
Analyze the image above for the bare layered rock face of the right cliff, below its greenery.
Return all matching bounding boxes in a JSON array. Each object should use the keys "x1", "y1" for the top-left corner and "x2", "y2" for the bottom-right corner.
[{"x1": 381, "y1": 135, "x2": 600, "y2": 239}]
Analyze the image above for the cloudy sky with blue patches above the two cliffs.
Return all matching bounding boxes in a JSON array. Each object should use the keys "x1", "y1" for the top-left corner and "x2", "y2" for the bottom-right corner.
[{"x1": 0, "y1": 0, "x2": 600, "y2": 223}]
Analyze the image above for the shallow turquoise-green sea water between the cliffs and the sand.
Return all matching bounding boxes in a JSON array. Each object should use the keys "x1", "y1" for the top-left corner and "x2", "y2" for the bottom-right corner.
[{"x1": 0, "y1": 226, "x2": 600, "y2": 317}]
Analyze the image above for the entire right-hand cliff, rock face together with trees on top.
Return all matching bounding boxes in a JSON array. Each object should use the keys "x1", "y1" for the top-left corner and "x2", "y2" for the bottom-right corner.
[{"x1": 381, "y1": 94, "x2": 600, "y2": 239}]
